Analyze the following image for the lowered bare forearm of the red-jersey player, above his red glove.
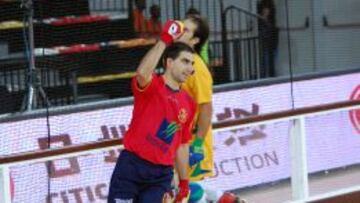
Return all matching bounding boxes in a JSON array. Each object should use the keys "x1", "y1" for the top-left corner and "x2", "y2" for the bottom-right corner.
[{"x1": 175, "y1": 144, "x2": 189, "y2": 180}]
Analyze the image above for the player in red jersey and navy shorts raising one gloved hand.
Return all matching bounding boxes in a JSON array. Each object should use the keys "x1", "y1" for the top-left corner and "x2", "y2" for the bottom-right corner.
[{"x1": 108, "y1": 21, "x2": 196, "y2": 203}]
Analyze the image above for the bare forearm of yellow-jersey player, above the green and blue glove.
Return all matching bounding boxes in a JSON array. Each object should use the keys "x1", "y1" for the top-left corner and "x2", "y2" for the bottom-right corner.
[{"x1": 196, "y1": 102, "x2": 213, "y2": 138}]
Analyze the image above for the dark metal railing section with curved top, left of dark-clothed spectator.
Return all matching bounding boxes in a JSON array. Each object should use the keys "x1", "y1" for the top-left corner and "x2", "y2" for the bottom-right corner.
[{"x1": 221, "y1": 6, "x2": 265, "y2": 81}]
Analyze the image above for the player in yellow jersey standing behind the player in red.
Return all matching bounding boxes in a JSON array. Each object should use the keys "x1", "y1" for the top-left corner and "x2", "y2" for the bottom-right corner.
[{"x1": 178, "y1": 15, "x2": 214, "y2": 181}]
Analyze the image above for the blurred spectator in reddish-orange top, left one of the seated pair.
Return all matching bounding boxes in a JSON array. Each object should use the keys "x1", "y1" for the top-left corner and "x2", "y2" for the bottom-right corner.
[{"x1": 133, "y1": 0, "x2": 146, "y2": 35}]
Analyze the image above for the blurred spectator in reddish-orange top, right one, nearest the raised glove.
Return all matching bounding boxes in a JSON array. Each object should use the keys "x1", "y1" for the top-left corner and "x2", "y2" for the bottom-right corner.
[{"x1": 146, "y1": 4, "x2": 161, "y2": 36}]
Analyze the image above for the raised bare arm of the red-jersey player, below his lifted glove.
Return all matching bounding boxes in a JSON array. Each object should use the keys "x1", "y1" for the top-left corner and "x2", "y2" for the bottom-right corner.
[{"x1": 136, "y1": 41, "x2": 166, "y2": 87}]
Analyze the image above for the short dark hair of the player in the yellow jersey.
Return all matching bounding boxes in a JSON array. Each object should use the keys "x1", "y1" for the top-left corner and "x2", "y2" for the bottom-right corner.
[{"x1": 187, "y1": 15, "x2": 210, "y2": 53}]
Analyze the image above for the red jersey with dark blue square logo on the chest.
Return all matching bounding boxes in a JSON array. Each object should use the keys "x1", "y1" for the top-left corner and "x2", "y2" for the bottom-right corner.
[{"x1": 124, "y1": 75, "x2": 196, "y2": 165}]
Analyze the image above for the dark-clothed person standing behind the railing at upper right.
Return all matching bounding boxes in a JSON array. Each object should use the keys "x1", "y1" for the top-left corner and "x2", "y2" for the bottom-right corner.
[{"x1": 257, "y1": 0, "x2": 279, "y2": 78}]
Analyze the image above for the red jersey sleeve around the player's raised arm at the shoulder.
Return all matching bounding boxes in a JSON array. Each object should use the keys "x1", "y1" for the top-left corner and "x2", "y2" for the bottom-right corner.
[{"x1": 131, "y1": 74, "x2": 159, "y2": 97}]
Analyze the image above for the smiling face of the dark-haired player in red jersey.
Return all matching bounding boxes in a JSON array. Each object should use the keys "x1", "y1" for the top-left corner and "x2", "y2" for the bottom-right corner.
[{"x1": 167, "y1": 51, "x2": 194, "y2": 83}]
